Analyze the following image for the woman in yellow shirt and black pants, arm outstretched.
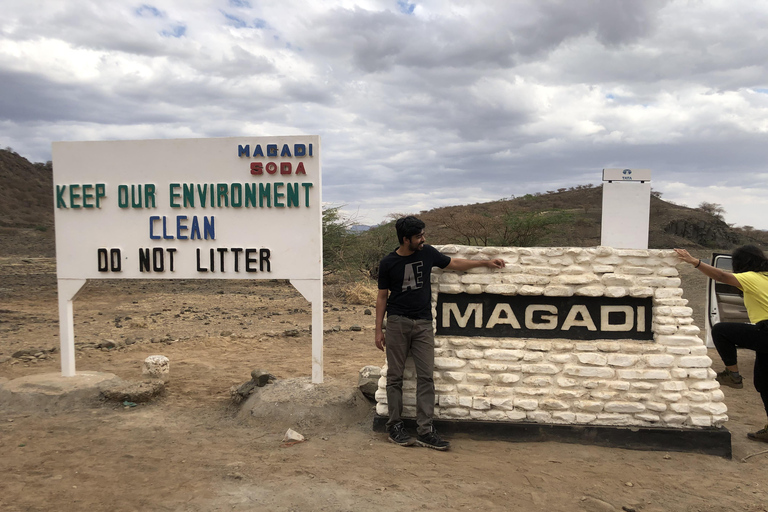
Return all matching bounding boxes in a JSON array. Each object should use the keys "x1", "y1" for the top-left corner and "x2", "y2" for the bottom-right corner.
[{"x1": 675, "y1": 245, "x2": 768, "y2": 442}]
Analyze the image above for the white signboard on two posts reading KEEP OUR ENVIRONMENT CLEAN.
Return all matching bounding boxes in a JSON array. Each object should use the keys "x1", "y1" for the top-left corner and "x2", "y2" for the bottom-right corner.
[{"x1": 53, "y1": 136, "x2": 322, "y2": 380}]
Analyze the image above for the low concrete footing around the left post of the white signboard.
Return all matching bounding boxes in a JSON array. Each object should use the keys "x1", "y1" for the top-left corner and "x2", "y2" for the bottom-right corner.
[{"x1": 0, "y1": 372, "x2": 120, "y2": 412}]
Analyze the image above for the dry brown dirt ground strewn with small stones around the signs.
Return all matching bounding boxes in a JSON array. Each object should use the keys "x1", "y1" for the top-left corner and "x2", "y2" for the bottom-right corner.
[{"x1": 0, "y1": 256, "x2": 768, "y2": 512}]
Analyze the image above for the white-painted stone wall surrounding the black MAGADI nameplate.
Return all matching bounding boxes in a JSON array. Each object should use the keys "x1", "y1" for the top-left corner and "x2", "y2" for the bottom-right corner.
[{"x1": 376, "y1": 245, "x2": 728, "y2": 428}]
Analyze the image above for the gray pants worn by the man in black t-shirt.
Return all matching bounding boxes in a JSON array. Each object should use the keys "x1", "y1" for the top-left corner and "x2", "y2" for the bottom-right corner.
[{"x1": 385, "y1": 315, "x2": 435, "y2": 435}]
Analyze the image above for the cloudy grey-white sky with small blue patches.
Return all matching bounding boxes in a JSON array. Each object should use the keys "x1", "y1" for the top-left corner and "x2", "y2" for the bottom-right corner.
[{"x1": 0, "y1": 0, "x2": 768, "y2": 229}]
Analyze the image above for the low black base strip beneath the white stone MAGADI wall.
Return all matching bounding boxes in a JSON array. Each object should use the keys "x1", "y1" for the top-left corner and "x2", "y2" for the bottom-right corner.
[{"x1": 373, "y1": 414, "x2": 732, "y2": 459}]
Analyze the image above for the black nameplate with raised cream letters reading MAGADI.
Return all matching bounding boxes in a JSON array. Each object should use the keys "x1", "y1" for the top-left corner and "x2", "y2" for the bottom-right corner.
[{"x1": 437, "y1": 293, "x2": 653, "y2": 340}]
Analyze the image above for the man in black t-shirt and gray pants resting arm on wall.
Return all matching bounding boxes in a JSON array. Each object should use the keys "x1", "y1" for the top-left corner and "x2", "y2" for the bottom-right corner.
[{"x1": 376, "y1": 216, "x2": 504, "y2": 450}]
